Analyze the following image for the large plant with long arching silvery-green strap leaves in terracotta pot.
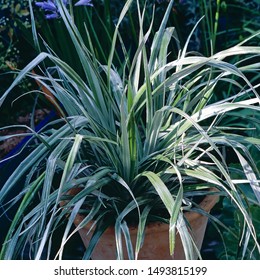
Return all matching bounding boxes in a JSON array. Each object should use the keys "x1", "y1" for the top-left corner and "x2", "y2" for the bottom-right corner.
[{"x1": 0, "y1": 0, "x2": 260, "y2": 259}]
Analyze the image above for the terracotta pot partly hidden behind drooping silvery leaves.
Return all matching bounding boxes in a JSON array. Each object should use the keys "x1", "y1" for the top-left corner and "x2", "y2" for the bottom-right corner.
[{"x1": 71, "y1": 189, "x2": 218, "y2": 260}]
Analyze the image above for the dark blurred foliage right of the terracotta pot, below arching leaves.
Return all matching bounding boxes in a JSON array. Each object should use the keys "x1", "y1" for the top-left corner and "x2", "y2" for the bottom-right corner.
[{"x1": 202, "y1": 187, "x2": 260, "y2": 260}]
